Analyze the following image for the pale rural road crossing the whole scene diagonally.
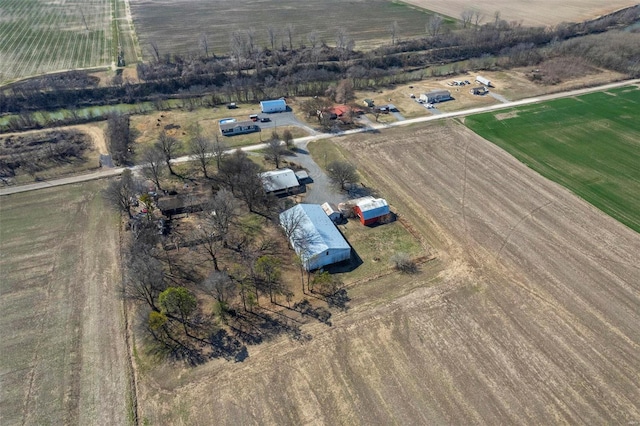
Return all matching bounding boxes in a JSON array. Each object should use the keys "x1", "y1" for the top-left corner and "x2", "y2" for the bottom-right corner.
[{"x1": 0, "y1": 79, "x2": 640, "y2": 196}]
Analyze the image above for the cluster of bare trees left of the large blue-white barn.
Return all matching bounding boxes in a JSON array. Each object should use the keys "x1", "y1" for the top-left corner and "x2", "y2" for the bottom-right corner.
[{"x1": 110, "y1": 150, "x2": 349, "y2": 363}]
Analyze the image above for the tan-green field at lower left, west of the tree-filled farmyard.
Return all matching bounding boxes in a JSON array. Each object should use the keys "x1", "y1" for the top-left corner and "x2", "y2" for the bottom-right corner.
[{"x1": 0, "y1": 181, "x2": 131, "y2": 425}]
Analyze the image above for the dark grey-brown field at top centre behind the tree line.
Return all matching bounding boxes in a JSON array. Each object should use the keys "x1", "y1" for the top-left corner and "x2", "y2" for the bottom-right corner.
[{"x1": 131, "y1": 0, "x2": 442, "y2": 58}]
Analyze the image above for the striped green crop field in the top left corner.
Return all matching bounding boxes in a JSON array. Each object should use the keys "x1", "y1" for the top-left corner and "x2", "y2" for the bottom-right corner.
[{"x1": 0, "y1": 0, "x2": 135, "y2": 83}]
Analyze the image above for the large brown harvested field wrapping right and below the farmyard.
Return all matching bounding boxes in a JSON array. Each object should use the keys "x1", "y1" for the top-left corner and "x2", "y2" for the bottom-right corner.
[{"x1": 139, "y1": 122, "x2": 640, "y2": 425}]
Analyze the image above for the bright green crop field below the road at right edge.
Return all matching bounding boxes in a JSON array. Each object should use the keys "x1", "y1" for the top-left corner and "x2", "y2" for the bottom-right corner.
[{"x1": 465, "y1": 86, "x2": 640, "y2": 232}]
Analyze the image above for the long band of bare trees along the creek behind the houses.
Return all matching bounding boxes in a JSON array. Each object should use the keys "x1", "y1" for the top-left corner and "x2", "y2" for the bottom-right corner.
[{"x1": 0, "y1": 6, "x2": 640, "y2": 131}]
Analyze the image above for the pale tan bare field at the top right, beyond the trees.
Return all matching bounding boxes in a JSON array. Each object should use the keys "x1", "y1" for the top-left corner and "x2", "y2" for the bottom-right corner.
[{"x1": 406, "y1": 0, "x2": 637, "y2": 26}]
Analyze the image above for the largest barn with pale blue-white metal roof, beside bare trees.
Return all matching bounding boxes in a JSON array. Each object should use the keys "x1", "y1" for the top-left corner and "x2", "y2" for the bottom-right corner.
[{"x1": 280, "y1": 204, "x2": 351, "y2": 271}]
